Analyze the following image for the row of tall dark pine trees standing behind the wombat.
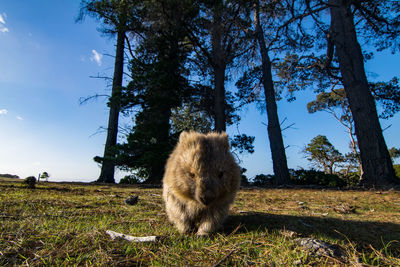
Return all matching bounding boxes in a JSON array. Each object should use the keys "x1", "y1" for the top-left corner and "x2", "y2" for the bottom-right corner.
[{"x1": 79, "y1": 0, "x2": 400, "y2": 187}]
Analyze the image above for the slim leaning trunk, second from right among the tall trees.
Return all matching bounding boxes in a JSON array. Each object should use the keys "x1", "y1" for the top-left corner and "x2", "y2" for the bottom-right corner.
[{"x1": 254, "y1": 0, "x2": 290, "y2": 185}]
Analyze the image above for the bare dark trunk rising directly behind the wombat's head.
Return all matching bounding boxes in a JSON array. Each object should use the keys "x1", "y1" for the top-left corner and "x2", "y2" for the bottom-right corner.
[{"x1": 211, "y1": 12, "x2": 226, "y2": 132}]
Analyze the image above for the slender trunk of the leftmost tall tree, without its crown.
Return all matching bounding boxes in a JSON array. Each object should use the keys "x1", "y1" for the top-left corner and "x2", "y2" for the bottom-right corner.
[{"x1": 97, "y1": 31, "x2": 125, "y2": 183}]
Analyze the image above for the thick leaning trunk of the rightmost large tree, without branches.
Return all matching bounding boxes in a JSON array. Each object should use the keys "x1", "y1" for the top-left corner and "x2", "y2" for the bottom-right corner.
[{"x1": 329, "y1": 0, "x2": 397, "y2": 187}]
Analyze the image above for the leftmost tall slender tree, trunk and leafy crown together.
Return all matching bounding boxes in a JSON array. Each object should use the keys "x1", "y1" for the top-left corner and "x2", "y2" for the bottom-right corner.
[{"x1": 78, "y1": 0, "x2": 138, "y2": 183}]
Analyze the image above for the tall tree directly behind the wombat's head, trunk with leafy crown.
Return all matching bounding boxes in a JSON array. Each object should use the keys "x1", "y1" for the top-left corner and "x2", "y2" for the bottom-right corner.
[{"x1": 181, "y1": 0, "x2": 249, "y2": 132}]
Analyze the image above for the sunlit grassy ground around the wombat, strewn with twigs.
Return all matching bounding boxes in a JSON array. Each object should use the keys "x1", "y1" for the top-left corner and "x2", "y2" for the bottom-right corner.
[{"x1": 0, "y1": 179, "x2": 400, "y2": 266}]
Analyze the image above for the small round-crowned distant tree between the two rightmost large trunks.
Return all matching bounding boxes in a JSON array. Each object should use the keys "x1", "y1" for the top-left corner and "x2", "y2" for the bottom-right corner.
[{"x1": 303, "y1": 135, "x2": 344, "y2": 174}]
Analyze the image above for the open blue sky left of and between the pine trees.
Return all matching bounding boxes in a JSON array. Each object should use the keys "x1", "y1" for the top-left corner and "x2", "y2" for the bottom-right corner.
[{"x1": 0, "y1": 0, "x2": 400, "y2": 181}]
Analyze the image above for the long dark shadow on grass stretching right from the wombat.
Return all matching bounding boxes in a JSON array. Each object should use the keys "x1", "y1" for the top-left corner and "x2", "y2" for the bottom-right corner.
[{"x1": 224, "y1": 212, "x2": 400, "y2": 252}]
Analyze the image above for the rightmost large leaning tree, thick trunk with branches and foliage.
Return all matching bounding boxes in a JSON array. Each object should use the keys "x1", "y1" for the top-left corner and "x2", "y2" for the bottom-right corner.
[{"x1": 278, "y1": 0, "x2": 400, "y2": 187}]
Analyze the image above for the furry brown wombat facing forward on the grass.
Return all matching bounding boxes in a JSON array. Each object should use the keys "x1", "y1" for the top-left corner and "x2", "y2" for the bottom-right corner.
[{"x1": 163, "y1": 131, "x2": 241, "y2": 235}]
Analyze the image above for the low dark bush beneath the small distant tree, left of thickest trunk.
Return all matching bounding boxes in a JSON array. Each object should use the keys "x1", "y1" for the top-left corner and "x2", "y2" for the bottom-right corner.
[{"x1": 290, "y1": 169, "x2": 346, "y2": 187}]
